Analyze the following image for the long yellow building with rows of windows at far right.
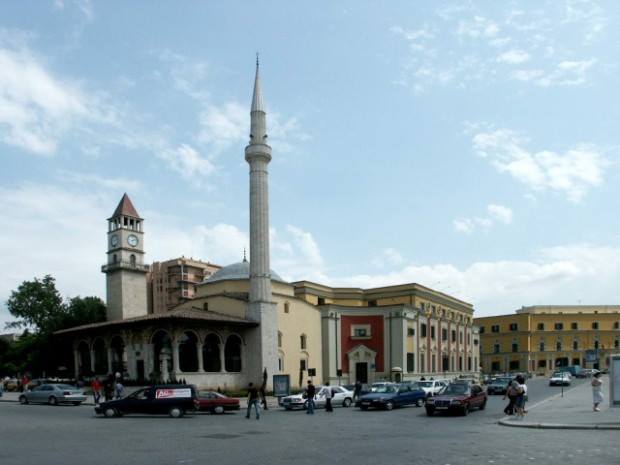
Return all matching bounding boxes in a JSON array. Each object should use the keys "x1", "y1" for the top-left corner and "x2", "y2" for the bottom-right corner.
[{"x1": 474, "y1": 305, "x2": 620, "y2": 375}]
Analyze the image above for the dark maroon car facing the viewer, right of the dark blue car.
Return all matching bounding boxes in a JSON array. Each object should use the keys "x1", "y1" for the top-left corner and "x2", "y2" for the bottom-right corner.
[{"x1": 425, "y1": 382, "x2": 487, "y2": 416}]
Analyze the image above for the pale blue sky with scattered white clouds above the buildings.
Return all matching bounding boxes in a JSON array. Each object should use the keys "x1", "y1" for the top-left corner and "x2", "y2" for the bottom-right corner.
[{"x1": 0, "y1": 0, "x2": 620, "y2": 326}]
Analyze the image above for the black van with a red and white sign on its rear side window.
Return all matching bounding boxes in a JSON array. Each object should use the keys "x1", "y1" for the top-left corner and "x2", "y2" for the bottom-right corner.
[{"x1": 95, "y1": 384, "x2": 199, "y2": 418}]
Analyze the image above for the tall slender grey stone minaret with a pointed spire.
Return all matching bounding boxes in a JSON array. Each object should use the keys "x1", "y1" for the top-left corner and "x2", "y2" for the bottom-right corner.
[{"x1": 245, "y1": 55, "x2": 278, "y2": 385}]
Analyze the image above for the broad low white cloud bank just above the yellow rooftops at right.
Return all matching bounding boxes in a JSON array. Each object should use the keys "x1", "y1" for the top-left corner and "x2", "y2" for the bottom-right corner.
[{"x1": 330, "y1": 244, "x2": 620, "y2": 316}]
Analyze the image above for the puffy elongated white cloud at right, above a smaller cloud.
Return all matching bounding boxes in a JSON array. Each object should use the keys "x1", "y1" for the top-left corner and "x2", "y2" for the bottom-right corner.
[{"x1": 472, "y1": 129, "x2": 608, "y2": 202}]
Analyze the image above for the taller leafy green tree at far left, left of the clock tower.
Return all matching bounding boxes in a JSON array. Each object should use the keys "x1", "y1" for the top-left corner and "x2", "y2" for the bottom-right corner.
[{"x1": 6, "y1": 275, "x2": 65, "y2": 332}]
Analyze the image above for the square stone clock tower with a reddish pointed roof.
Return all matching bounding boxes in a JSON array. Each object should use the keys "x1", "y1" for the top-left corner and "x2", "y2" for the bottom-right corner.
[{"x1": 101, "y1": 194, "x2": 148, "y2": 321}]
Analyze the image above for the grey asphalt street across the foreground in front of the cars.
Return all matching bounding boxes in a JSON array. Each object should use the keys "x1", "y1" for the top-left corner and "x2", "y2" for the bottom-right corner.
[{"x1": 0, "y1": 379, "x2": 620, "y2": 465}]
